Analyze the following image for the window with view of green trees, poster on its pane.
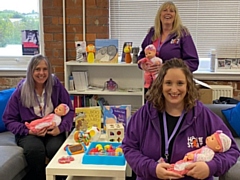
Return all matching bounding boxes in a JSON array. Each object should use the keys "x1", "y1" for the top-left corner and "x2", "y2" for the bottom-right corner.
[{"x1": 0, "y1": 0, "x2": 44, "y2": 70}]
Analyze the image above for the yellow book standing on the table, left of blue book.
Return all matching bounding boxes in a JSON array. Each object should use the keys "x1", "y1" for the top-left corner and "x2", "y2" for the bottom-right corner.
[{"x1": 75, "y1": 106, "x2": 102, "y2": 130}]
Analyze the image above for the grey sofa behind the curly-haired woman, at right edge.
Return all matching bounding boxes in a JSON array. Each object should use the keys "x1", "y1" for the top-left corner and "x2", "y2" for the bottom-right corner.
[{"x1": 205, "y1": 104, "x2": 240, "y2": 180}]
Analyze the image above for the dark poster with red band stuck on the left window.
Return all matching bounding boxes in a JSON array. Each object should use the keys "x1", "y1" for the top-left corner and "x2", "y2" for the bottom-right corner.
[{"x1": 22, "y1": 30, "x2": 39, "y2": 55}]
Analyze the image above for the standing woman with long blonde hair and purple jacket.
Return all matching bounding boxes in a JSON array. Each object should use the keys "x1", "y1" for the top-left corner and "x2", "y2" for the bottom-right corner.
[{"x1": 138, "y1": 1, "x2": 199, "y2": 92}]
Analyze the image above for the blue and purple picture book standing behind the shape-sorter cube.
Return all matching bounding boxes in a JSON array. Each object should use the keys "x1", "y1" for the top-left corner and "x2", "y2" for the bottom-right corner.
[{"x1": 102, "y1": 105, "x2": 131, "y2": 133}]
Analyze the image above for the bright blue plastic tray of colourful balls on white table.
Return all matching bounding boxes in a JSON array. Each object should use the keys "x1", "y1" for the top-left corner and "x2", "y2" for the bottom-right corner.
[{"x1": 82, "y1": 142, "x2": 126, "y2": 166}]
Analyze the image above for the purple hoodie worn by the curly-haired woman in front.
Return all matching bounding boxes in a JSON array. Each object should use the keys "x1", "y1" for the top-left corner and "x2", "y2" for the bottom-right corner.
[{"x1": 123, "y1": 102, "x2": 240, "y2": 180}]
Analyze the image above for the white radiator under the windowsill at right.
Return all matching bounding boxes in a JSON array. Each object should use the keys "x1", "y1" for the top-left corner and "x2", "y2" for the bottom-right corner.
[{"x1": 210, "y1": 85, "x2": 233, "y2": 100}]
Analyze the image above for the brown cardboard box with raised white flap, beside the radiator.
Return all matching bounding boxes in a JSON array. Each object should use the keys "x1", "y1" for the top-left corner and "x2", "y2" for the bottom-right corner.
[{"x1": 194, "y1": 79, "x2": 213, "y2": 104}]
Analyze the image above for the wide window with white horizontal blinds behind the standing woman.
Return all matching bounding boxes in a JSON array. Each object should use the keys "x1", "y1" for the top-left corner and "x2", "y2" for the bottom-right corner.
[{"x1": 109, "y1": 0, "x2": 240, "y2": 70}]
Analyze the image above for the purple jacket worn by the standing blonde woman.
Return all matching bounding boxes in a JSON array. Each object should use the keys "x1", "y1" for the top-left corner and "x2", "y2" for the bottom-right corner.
[{"x1": 138, "y1": 27, "x2": 199, "y2": 72}]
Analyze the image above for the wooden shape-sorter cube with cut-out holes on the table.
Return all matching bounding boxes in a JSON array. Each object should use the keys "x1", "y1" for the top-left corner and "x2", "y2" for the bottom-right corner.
[{"x1": 106, "y1": 123, "x2": 124, "y2": 142}]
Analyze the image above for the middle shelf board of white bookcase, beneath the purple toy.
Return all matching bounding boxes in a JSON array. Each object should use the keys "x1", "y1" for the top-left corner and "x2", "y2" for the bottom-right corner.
[{"x1": 68, "y1": 90, "x2": 143, "y2": 96}]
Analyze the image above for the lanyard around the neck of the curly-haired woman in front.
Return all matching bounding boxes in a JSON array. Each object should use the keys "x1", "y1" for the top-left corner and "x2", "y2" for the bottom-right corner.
[{"x1": 163, "y1": 111, "x2": 185, "y2": 160}]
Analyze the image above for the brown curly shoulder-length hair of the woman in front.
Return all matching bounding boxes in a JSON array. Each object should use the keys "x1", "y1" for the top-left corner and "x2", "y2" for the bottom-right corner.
[{"x1": 146, "y1": 58, "x2": 199, "y2": 112}]
